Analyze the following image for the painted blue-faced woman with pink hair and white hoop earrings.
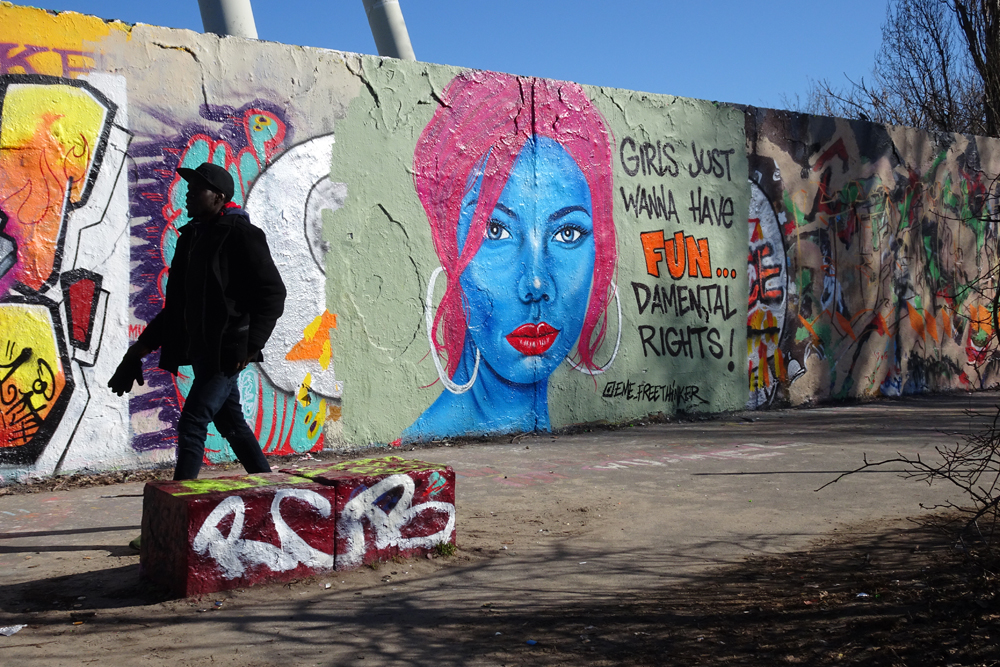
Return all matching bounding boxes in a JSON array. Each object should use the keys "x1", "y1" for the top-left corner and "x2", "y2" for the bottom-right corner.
[{"x1": 402, "y1": 72, "x2": 621, "y2": 441}]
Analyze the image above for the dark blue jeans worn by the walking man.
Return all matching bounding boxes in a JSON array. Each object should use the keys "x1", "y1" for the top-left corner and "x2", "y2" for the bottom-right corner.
[{"x1": 174, "y1": 363, "x2": 271, "y2": 480}]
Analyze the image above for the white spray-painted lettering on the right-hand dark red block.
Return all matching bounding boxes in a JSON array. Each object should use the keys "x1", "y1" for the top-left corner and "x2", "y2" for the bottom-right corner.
[{"x1": 337, "y1": 475, "x2": 455, "y2": 570}]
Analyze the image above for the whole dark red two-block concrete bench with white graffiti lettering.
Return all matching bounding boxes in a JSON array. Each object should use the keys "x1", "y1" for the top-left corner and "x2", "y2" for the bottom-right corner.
[{"x1": 139, "y1": 456, "x2": 455, "y2": 597}]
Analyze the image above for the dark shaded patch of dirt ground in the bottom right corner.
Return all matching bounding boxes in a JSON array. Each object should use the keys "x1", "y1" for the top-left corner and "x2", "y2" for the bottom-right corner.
[{"x1": 533, "y1": 523, "x2": 1000, "y2": 667}]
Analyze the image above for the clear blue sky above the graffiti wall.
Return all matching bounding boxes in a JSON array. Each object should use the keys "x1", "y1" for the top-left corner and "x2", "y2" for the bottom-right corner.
[{"x1": 36, "y1": 0, "x2": 886, "y2": 107}]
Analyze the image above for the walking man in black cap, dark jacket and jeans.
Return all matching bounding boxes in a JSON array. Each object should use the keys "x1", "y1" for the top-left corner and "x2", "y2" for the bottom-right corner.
[{"x1": 108, "y1": 163, "x2": 285, "y2": 480}]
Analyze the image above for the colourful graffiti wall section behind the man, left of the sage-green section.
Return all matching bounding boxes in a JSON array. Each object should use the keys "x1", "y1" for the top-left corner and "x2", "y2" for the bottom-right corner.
[{"x1": 0, "y1": 4, "x2": 363, "y2": 478}]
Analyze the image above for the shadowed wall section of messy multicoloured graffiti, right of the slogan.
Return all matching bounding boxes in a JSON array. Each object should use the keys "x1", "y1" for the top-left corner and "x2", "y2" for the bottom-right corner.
[{"x1": 747, "y1": 109, "x2": 1000, "y2": 407}]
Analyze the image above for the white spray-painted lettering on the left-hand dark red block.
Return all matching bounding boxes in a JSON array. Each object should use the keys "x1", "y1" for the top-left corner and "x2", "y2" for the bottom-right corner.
[{"x1": 192, "y1": 489, "x2": 333, "y2": 579}]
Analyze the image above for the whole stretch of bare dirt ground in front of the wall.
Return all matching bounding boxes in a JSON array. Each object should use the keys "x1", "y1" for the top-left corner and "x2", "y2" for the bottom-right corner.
[{"x1": 0, "y1": 399, "x2": 1000, "y2": 667}]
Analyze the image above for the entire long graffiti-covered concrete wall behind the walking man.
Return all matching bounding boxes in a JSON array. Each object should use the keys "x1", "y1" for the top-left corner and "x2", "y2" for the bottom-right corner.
[{"x1": 0, "y1": 3, "x2": 998, "y2": 479}]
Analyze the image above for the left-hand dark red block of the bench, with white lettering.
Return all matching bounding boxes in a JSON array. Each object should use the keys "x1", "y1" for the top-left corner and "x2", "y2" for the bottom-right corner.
[{"x1": 139, "y1": 473, "x2": 337, "y2": 597}]
